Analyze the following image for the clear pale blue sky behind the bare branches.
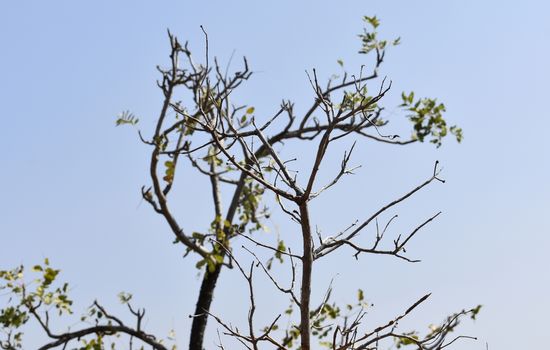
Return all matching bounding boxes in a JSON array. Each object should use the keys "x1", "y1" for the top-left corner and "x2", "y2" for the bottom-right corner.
[{"x1": 0, "y1": 0, "x2": 550, "y2": 350}]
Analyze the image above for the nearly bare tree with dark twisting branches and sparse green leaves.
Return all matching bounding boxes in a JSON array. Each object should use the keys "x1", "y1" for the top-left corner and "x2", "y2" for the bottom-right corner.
[{"x1": 0, "y1": 17, "x2": 480, "y2": 350}]
